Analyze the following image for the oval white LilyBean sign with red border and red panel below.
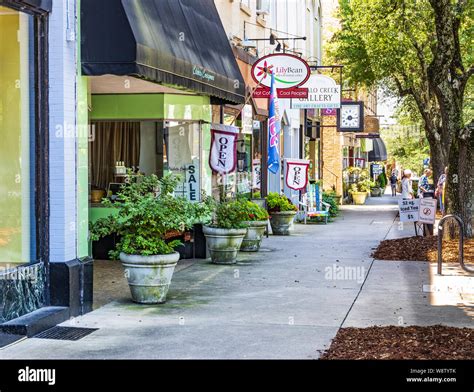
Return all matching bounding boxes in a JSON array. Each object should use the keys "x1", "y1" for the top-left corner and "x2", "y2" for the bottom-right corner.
[{"x1": 251, "y1": 53, "x2": 311, "y2": 98}]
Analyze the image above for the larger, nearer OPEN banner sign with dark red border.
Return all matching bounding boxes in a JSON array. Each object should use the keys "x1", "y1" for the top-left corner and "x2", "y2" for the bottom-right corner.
[{"x1": 209, "y1": 124, "x2": 239, "y2": 174}]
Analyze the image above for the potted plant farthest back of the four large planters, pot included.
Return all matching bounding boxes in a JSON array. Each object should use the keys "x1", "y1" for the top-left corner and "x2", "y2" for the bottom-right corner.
[{"x1": 266, "y1": 192, "x2": 298, "y2": 235}]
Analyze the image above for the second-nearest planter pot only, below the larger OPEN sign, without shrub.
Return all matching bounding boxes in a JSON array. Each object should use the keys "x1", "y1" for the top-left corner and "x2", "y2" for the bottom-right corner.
[{"x1": 203, "y1": 226, "x2": 247, "y2": 264}]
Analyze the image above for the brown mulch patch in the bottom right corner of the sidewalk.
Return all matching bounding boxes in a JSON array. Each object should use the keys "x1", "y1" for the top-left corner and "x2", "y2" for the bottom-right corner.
[{"x1": 321, "y1": 325, "x2": 474, "y2": 360}]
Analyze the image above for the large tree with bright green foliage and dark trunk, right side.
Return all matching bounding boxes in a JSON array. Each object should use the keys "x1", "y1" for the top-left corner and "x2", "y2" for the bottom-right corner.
[{"x1": 329, "y1": 0, "x2": 474, "y2": 234}]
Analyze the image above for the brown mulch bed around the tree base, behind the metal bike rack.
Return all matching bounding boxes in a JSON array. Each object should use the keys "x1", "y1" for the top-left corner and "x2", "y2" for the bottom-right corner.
[{"x1": 372, "y1": 236, "x2": 474, "y2": 263}]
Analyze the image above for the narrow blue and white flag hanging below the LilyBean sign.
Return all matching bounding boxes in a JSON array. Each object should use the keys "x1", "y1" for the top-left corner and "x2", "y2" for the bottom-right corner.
[{"x1": 267, "y1": 73, "x2": 280, "y2": 174}]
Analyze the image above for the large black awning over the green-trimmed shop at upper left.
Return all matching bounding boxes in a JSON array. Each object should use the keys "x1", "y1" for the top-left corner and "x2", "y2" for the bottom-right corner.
[{"x1": 81, "y1": 0, "x2": 245, "y2": 103}]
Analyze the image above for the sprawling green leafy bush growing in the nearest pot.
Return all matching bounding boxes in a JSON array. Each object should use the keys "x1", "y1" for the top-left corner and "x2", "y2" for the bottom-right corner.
[{"x1": 90, "y1": 175, "x2": 211, "y2": 259}]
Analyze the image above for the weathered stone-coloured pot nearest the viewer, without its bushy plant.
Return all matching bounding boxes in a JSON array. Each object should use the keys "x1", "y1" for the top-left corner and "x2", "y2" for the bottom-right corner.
[{"x1": 120, "y1": 252, "x2": 179, "y2": 304}]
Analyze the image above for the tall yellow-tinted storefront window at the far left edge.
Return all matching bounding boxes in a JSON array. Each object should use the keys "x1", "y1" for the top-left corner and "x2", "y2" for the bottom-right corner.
[{"x1": 0, "y1": 7, "x2": 36, "y2": 264}]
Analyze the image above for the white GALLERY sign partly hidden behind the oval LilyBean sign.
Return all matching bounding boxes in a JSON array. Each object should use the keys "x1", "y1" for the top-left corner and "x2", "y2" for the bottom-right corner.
[{"x1": 291, "y1": 73, "x2": 341, "y2": 109}]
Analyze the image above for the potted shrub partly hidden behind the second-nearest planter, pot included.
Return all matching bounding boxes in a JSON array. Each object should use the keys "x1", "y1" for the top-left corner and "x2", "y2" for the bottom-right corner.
[{"x1": 240, "y1": 201, "x2": 269, "y2": 252}]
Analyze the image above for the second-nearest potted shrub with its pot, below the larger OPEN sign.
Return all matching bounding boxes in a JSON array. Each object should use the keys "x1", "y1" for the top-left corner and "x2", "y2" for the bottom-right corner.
[{"x1": 203, "y1": 200, "x2": 248, "y2": 264}]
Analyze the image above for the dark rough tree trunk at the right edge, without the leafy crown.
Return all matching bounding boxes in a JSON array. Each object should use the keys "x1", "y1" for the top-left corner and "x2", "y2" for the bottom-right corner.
[{"x1": 428, "y1": 0, "x2": 474, "y2": 235}]
